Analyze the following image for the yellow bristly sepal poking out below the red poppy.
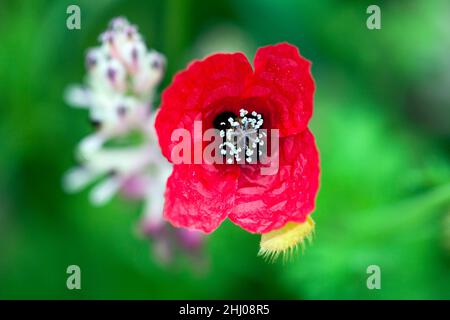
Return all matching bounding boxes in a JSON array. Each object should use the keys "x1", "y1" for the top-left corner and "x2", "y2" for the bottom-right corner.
[{"x1": 258, "y1": 216, "x2": 315, "y2": 261}]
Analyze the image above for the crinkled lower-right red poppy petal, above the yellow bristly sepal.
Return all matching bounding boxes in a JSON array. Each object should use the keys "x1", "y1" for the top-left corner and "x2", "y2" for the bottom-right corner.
[{"x1": 229, "y1": 129, "x2": 319, "y2": 233}]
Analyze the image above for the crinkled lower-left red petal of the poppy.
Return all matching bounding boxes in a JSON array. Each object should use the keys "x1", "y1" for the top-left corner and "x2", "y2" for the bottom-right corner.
[{"x1": 164, "y1": 164, "x2": 239, "y2": 233}]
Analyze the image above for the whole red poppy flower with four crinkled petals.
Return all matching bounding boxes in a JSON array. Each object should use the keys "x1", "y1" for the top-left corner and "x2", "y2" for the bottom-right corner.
[{"x1": 155, "y1": 43, "x2": 319, "y2": 258}]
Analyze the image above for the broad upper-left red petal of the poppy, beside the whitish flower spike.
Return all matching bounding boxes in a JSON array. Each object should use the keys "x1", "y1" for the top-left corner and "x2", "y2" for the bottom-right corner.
[{"x1": 155, "y1": 53, "x2": 252, "y2": 160}]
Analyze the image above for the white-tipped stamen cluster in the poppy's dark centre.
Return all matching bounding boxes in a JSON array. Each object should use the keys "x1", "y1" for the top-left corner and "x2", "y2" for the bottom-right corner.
[{"x1": 219, "y1": 109, "x2": 266, "y2": 164}]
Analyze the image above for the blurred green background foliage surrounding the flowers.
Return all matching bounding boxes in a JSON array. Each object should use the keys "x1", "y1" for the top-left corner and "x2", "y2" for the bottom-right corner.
[{"x1": 0, "y1": 0, "x2": 450, "y2": 299}]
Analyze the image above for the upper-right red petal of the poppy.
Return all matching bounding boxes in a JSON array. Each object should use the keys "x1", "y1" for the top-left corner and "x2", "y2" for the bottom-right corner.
[{"x1": 245, "y1": 43, "x2": 314, "y2": 137}]
